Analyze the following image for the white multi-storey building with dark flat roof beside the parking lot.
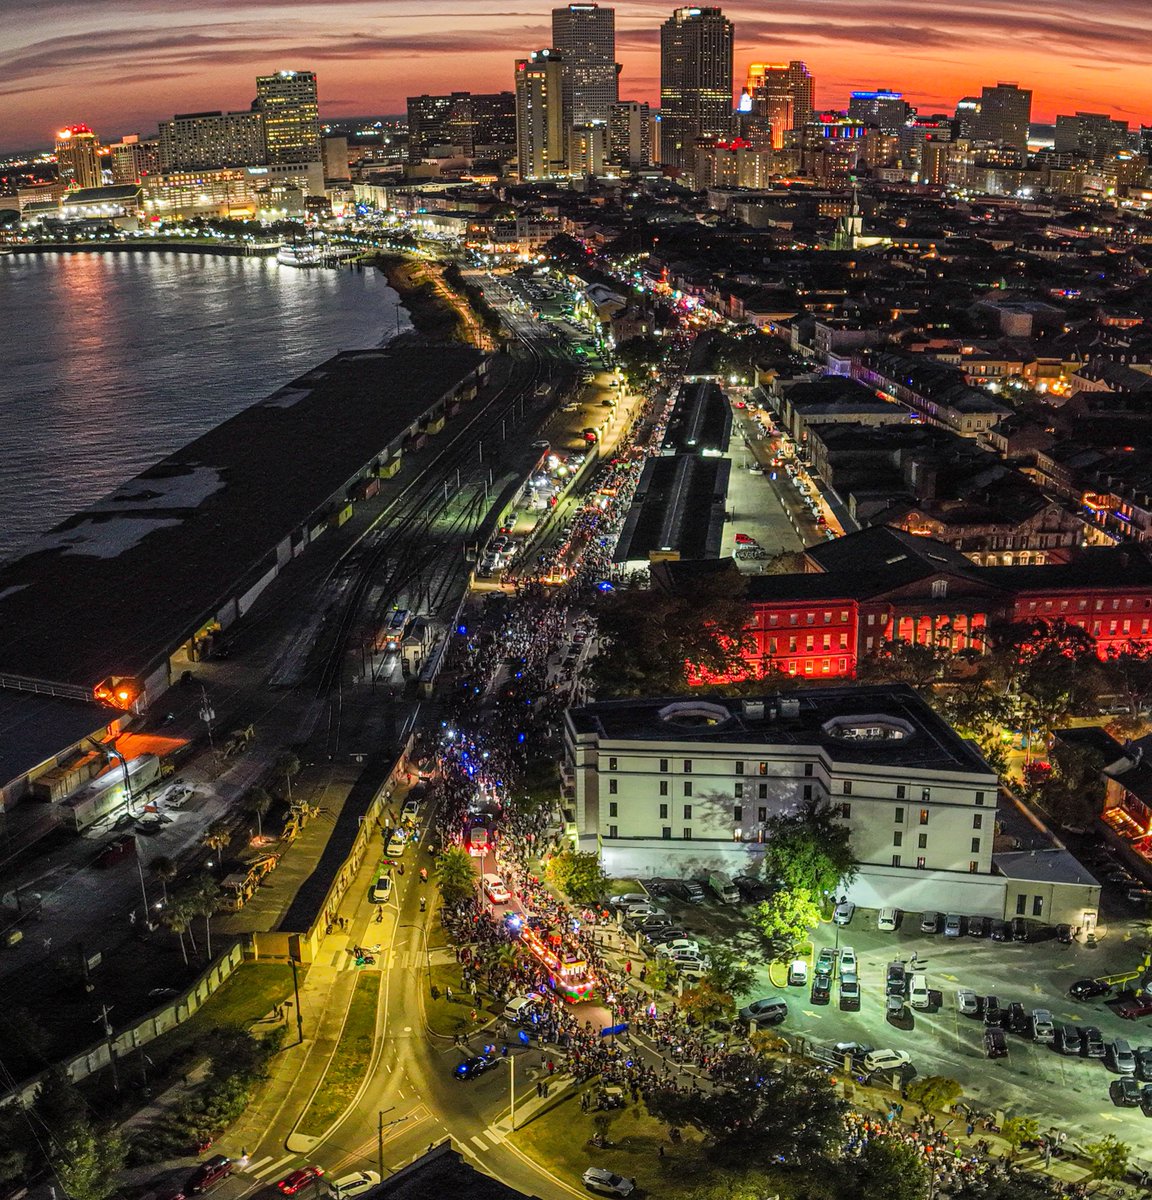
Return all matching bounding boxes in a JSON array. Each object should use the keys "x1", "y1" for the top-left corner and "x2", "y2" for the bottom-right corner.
[{"x1": 564, "y1": 684, "x2": 1099, "y2": 928}]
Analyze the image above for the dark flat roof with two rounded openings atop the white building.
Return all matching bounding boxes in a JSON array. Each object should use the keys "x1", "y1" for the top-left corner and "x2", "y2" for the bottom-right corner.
[{"x1": 568, "y1": 684, "x2": 996, "y2": 790}]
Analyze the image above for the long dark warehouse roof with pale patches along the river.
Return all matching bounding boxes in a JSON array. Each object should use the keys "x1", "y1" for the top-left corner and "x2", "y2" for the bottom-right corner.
[{"x1": 0, "y1": 346, "x2": 484, "y2": 691}]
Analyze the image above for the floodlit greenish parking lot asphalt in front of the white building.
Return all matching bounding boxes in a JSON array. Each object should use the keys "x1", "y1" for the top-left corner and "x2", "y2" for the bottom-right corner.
[{"x1": 624, "y1": 896, "x2": 1152, "y2": 1153}]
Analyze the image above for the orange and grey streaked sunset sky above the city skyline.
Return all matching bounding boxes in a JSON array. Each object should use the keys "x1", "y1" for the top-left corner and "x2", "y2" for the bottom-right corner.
[{"x1": 0, "y1": 0, "x2": 1152, "y2": 150}]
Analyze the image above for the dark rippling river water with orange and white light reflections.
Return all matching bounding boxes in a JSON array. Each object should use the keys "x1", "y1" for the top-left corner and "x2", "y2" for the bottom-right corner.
[{"x1": 0, "y1": 251, "x2": 408, "y2": 560}]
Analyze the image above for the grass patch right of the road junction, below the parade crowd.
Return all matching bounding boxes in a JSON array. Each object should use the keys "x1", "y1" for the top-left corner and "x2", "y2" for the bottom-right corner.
[{"x1": 512, "y1": 1085, "x2": 715, "y2": 1200}]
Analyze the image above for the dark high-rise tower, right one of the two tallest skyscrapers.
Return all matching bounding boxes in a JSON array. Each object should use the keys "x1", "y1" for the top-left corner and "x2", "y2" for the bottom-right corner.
[{"x1": 660, "y1": 8, "x2": 733, "y2": 170}]
